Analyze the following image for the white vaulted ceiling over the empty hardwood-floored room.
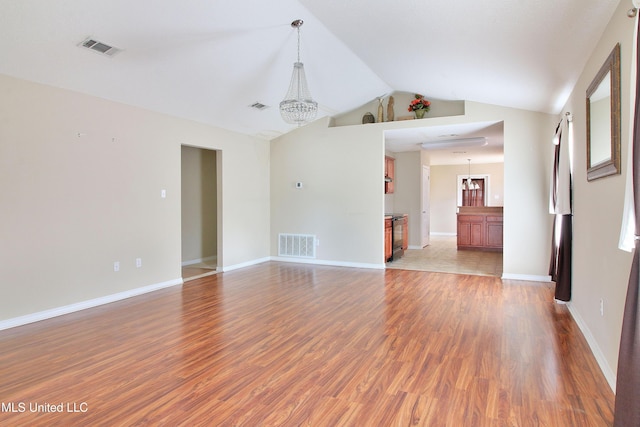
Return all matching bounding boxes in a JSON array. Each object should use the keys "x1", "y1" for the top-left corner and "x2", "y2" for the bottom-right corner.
[{"x1": 0, "y1": 0, "x2": 619, "y2": 161}]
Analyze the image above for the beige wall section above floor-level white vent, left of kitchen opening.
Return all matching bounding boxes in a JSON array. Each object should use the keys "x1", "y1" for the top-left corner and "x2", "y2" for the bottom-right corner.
[{"x1": 271, "y1": 120, "x2": 384, "y2": 266}]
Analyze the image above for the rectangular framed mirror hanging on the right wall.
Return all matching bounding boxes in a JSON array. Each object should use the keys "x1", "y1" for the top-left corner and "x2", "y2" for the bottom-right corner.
[{"x1": 587, "y1": 43, "x2": 620, "y2": 181}]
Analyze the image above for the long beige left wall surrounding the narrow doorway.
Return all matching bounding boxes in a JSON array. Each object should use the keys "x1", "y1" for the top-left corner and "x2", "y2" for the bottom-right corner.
[{"x1": 0, "y1": 76, "x2": 270, "y2": 320}]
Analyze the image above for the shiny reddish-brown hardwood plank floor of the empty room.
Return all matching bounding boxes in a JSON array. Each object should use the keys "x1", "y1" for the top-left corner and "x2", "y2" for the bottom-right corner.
[{"x1": 0, "y1": 262, "x2": 613, "y2": 426}]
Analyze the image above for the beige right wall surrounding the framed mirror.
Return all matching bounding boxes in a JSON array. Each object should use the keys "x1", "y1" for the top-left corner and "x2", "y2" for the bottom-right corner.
[{"x1": 564, "y1": 2, "x2": 633, "y2": 388}]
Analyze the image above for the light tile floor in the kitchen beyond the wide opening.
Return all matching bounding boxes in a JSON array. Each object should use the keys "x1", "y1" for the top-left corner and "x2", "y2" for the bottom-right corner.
[{"x1": 387, "y1": 236, "x2": 502, "y2": 277}]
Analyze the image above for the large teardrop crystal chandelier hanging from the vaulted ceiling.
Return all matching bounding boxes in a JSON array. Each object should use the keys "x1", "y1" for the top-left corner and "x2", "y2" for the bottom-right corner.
[{"x1": 280, "y1": 19, "x2": 318, "y2": 126}]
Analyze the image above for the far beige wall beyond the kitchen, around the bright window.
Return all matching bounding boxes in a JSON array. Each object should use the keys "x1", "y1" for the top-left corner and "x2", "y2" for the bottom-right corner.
[{"x1": 431, "y1": 163, "x2": 504, "y2": 234}]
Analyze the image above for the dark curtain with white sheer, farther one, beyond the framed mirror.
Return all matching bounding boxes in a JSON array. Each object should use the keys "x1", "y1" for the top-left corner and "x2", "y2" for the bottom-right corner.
[{"x1": 549, "y1": 118, "x2": 573, "y2": 301}]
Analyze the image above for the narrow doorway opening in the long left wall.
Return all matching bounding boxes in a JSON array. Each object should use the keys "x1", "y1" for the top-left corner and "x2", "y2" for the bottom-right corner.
[{"x1": 181, "y1": 145, "x2": 221, "y2": 281}]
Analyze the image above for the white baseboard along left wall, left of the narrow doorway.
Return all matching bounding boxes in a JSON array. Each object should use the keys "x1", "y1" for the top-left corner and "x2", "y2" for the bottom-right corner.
[{"x1": 0, "y1": 279, "x2": 182, "y2": 331}]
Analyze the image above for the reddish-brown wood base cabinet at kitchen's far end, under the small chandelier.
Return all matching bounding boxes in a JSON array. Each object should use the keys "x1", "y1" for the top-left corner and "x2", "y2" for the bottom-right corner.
[{"x1": 457, "y1": 206, "x2": 503, "y2": 251}]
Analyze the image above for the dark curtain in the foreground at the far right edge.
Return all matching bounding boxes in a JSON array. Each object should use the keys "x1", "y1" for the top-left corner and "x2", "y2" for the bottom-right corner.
[{"x1": 613, "y1": 13, "x2": 640, "y2": 427}]
